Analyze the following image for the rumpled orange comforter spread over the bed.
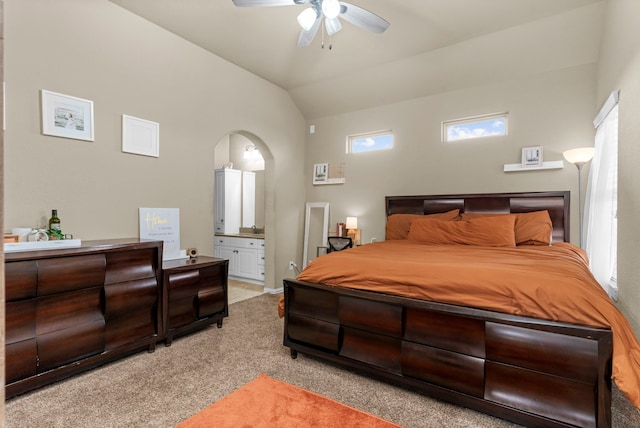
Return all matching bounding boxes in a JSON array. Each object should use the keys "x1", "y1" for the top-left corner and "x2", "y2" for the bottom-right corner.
[{"x1": 298, "y1": 240, "x2": 640, "y2": 408}]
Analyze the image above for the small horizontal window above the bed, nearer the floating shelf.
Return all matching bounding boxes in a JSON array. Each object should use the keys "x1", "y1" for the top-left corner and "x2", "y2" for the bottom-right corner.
[{"x1": 442, "y1": 113, "x2": 509, "y2": 143}]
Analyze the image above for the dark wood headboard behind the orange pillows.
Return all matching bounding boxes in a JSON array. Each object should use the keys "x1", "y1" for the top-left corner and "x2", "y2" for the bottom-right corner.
[{"x1": 385, "y1": 191, "x2": 570, "y2": 242}]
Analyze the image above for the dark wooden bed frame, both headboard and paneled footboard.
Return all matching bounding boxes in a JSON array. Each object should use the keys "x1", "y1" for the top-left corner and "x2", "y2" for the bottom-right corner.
[{"x1": 284, "y1": 192, "x2": 612, "y2": 427}]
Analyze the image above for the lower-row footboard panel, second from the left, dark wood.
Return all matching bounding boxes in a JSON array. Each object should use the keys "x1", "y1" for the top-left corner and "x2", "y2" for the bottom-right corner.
[{"x1": 340, "y1": 327, "x2": 402, "y2": 373}]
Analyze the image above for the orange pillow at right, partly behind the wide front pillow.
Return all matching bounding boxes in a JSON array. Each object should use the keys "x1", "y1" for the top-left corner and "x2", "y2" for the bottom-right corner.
[{"x1": 460, "y1": 210, "x2": 553, "y2": 245}]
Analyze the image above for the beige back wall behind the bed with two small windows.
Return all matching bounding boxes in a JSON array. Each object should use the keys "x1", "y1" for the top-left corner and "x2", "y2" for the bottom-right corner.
[{"x1": 304, "y1": 64, "x2": 595, "y2": 247}]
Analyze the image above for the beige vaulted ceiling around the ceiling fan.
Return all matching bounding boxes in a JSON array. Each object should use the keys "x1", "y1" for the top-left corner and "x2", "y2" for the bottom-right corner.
[{"x1": 110, "y1": 0, "x2": 605, "y2": 119}]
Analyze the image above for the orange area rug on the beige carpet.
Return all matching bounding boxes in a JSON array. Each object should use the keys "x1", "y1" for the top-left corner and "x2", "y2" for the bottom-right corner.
[{"x1": 177, "y1": 374, "x2": 400, "y2": 428}]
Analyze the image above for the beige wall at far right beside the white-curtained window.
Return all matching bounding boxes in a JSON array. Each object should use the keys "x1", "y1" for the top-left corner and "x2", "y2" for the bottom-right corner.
[{"x1": 597, "y1": 0, "x2": 640, "y2": 336}]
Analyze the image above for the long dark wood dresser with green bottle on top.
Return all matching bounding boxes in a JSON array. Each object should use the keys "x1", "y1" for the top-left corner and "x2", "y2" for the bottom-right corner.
[{"x1": 5, "y1": 239, "x2": 164, "y2": 397}]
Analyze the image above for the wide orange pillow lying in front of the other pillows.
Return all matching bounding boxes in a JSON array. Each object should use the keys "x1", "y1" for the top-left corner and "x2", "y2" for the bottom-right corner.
[{"x1": 409, "y1": 216, "x2": 516, "y2": 247}]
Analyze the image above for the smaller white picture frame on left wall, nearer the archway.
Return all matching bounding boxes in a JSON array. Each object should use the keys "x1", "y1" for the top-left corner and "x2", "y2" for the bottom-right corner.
[{"x1": 122, "y1": 114, "x2": 160, "y2": 158}]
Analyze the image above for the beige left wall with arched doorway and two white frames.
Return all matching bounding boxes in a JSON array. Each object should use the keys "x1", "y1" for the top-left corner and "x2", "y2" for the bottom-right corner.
[{"x1": 4, "y1": 0, "x2": 304, "y2": 288}]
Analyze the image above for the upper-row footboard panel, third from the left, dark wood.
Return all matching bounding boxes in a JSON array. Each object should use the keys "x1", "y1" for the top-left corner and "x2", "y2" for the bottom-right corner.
[{"x1": 404, "y1": 308, "x2": 485, "y2": 358}]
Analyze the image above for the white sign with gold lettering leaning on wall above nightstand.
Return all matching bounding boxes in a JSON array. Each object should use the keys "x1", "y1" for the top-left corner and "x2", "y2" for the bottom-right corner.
[{"x1": 139, "y1": 208, "x2": 181, "y2": 260}]
